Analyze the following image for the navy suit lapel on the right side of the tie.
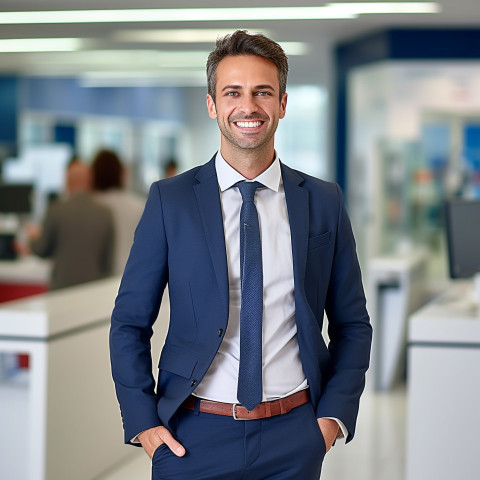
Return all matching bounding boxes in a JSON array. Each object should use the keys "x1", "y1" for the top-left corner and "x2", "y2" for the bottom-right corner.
[{"x1": 281, "y1": 164, "x2": 309, "y2": 293}]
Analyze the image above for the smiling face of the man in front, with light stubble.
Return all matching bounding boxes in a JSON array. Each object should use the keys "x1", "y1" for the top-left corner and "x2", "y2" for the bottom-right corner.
[{"x1": 207, "y1": 55, "x2": 287, "y2": 153}]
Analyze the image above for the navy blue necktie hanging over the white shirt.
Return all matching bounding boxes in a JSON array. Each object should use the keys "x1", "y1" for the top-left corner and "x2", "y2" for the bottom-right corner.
[{"x1": 237, "y1": 181, "x2": 263, "y2": 410}]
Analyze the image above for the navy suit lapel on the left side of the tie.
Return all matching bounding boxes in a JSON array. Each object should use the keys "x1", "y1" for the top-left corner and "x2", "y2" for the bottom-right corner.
[{"x1": 193, "y1": 157, "x2": 229, "y2": 317}]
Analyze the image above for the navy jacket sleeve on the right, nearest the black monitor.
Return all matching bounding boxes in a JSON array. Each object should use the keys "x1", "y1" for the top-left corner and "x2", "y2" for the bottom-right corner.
[{"x1": 317, "y1": 186, "x2": 372, "y2": 441}]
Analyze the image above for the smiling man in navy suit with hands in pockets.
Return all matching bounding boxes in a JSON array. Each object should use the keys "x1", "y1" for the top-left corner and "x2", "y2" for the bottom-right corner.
[{"x1": 110, "y1": 31, "x2": 371, "y2": 480}]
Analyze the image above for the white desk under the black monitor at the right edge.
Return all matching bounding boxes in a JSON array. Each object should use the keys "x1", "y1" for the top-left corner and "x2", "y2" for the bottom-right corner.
[{"x1": 406, "y1": 282, "x2": 480, "y2": 480}]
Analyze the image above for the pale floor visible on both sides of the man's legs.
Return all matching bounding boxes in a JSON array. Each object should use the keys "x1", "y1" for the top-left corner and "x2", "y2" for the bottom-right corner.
[{"x1": 95, "y1": 387, "x2": 406, "y2": 480}]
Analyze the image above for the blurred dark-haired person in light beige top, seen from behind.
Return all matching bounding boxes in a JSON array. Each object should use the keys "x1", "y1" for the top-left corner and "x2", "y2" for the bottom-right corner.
[{"x1": 92, "y1": 149, "x2": 145, "y2": 275}]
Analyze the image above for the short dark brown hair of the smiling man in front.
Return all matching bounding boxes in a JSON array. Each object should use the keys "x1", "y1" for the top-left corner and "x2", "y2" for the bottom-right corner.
[{"x1": 207, "y1": 30, "x2": 288, "y2": 102}]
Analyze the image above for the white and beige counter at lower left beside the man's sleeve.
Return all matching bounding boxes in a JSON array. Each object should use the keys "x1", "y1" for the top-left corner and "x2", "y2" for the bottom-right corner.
[{"x1": 0, "y1": 277, "x2": 168, "y2": 480}]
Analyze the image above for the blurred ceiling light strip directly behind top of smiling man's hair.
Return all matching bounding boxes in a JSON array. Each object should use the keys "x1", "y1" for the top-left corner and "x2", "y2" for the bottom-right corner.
[{"x1": 112, "y1": 28, "x2": 269, "y2": 43}]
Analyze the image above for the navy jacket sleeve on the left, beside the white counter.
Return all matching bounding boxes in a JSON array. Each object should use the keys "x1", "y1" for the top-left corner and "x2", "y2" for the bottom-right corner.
[{"x1": 110, "y1": 184, "x2": 168, "y2": 443}]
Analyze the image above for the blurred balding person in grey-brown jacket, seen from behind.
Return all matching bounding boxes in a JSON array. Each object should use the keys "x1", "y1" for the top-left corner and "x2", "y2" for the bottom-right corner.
[{"x1": 26, "y1": 161, "x2": 114, "y2": 290}]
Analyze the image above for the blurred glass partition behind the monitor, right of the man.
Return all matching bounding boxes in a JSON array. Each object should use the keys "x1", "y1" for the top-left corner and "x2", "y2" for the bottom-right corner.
[{"x1": 347, "y1": 62, "x2": 480, "y2": 280}]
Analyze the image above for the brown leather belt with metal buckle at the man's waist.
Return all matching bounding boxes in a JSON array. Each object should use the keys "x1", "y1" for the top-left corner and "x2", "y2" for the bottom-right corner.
[{"x1": 181, "y1": 389, "x2": 310, "y2": 420}]
